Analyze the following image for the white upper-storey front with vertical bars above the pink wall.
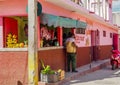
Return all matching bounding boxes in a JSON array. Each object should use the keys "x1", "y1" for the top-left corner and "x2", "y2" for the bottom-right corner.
[{"x1": 72, "y1": 0, "x2": 112, "y2": 22}]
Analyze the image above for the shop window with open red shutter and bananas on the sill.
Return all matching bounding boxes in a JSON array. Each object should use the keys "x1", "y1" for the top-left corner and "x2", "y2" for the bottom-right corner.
[{"x1": 3, "y1": 16, "x2": 28, "y2": 48}]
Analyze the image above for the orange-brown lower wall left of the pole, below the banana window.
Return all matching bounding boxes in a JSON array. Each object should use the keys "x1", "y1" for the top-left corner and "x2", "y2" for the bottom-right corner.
[{"x1": 0, "y1": 52, "x2": 28, "y2": 85}]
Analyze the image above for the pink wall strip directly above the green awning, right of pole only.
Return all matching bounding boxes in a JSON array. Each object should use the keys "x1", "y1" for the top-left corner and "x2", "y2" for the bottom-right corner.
[{"x1": 39, "y1": 0, "x2": 86, "y2": 21}]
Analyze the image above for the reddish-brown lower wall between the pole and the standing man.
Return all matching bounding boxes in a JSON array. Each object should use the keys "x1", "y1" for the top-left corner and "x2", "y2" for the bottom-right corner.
[{"x1": 38, "y1": 49, "x2": 66, "y2": 70}]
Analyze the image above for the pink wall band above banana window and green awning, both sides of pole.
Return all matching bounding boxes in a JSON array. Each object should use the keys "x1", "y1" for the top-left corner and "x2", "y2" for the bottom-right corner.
[{"x1": 0, "y1": 0, "x2": 85, "y2": 21}]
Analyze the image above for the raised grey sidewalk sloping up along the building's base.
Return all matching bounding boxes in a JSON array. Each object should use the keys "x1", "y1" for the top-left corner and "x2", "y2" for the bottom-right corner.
[{"x1": 38, "y1": 59, "x2": 110, "y2": 85}]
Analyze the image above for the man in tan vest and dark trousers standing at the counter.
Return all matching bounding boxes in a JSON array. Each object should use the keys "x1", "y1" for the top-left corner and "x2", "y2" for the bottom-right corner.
[{"x1": 66, "y1": 32, "x2": 78, "y2": 72}]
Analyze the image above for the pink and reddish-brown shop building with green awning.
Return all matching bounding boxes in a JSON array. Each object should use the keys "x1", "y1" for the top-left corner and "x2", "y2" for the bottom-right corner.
[{"x1": 0, "y1": 0, "x2": 119, "y2": 85}]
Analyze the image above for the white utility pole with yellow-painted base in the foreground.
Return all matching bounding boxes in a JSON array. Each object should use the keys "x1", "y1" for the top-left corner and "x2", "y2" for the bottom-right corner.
[{"x1": 28, "y1": 0, "x2": 38, "y2": 85}]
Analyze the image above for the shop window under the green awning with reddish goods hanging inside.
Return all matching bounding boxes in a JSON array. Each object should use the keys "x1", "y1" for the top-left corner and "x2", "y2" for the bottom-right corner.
[{"x1": 40, "y1": 24, "x2": 59, "y2": 47}]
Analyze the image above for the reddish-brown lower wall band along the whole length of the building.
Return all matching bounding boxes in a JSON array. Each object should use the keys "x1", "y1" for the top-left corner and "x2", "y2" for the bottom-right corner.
[{"x1": 0, "y1": 46, "x2": 111, "y2": 85}]
